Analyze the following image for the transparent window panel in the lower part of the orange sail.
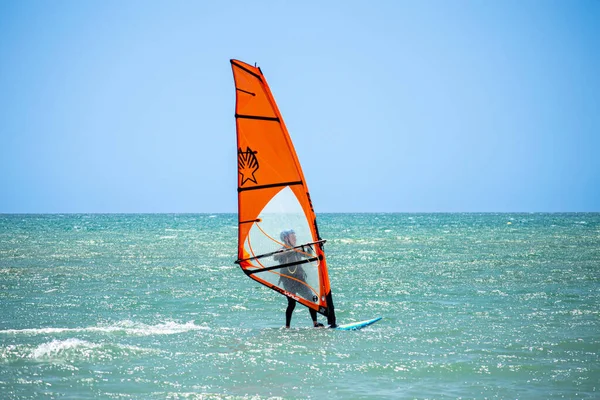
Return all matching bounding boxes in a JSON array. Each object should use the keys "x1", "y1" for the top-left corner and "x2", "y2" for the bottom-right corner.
[{"x1": 244, "y1": 186, "x2": 320, "y2": 303}]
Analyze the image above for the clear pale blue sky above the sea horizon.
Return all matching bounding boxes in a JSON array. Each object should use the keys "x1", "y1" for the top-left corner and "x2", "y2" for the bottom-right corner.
[{"x1": 0, "y1": 0, "x2": 600, "y2": 213}]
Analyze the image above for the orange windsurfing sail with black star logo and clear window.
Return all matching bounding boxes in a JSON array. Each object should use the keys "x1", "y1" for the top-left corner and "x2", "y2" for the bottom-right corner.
[{"x1": 231, "y1": 60, "x2": 335, "y2": 325}]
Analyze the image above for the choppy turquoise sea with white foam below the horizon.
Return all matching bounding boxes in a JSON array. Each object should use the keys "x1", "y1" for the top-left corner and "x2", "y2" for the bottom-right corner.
[{"x1": 0, "y1": 213, "x2": 600, "y2": 399}]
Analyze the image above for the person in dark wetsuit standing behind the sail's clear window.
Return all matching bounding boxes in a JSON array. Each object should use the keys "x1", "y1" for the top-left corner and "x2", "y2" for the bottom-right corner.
[{"x1": 273, "y1": 229, "x2": 324, "y2": 328}]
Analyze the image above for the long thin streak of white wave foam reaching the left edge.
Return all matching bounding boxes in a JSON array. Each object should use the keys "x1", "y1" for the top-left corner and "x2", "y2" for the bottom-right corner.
[{"x1": 0, "y1": 320, "x2": 210, "y2": 336}]
